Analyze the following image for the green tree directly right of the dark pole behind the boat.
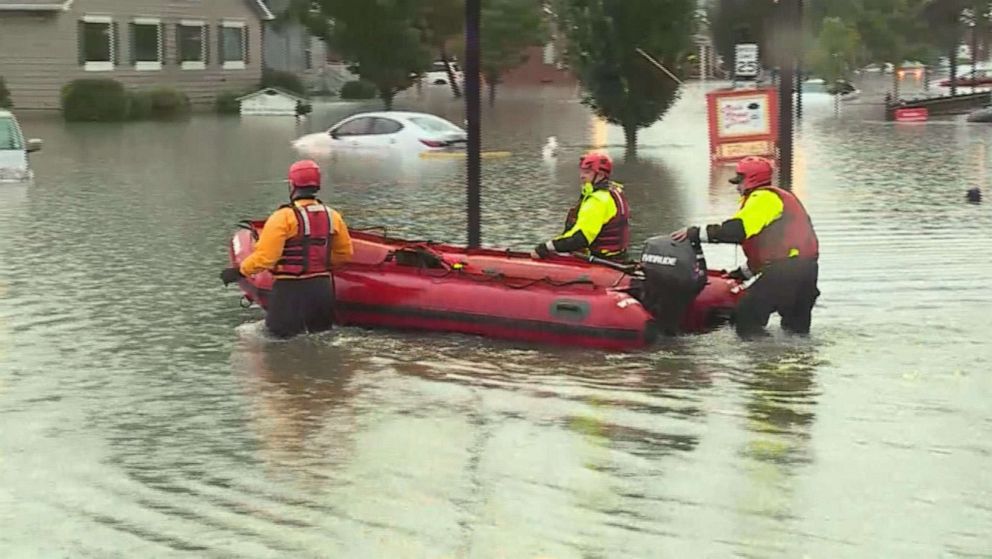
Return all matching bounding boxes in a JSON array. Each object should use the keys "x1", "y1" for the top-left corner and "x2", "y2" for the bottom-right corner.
[{"x1": 479, "y1": 0, "x2": 547, "y2": 105}]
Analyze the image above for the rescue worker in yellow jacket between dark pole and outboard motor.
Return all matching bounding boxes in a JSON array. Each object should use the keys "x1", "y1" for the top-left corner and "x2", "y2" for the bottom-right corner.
[{"x1": 531, "y1": 152, "x2": 630, "y2": 262}]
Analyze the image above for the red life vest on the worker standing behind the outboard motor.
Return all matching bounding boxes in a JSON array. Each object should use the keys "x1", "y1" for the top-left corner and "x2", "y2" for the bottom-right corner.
[{"x1": 741, "y1": 186, "x2": 820, "y2": 273}]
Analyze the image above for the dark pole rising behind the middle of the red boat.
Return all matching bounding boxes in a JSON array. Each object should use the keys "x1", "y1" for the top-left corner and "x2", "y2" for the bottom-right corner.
[{"x1": 465, "y1": 0, "x2": 482, "y2": 248}]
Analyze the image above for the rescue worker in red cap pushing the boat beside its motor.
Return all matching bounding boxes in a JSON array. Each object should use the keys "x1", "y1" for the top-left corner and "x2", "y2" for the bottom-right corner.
[{"x1": 672, "y1": 157, "x2": 820, "y2": 337}]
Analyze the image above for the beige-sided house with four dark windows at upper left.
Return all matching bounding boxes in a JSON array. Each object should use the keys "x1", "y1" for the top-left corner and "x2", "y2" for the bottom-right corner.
[{"x1": 0, "y1": 0, "x2": 273, "y2": 109}]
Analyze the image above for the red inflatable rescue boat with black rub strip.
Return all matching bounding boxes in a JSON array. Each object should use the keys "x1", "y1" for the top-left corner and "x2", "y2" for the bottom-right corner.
[{"x1": 230, "y1": 221, "x2": 739, "y2": 350}]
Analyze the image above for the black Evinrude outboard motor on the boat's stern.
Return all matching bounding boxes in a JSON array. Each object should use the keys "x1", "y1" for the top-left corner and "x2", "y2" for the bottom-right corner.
[{"x1": 640, "y1": 235, "x2": 706, "y2": 335}]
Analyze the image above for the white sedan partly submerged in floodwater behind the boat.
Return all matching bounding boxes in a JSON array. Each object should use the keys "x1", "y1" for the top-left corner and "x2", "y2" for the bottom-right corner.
[{"x1": 292, "y1": 111, "x2": 468, "y2": 155}]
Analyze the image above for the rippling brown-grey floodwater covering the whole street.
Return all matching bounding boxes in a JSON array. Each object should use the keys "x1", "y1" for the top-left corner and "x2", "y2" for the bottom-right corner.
[{"x1": 0, "y1": 80, "x2": 992, "y2": 558}]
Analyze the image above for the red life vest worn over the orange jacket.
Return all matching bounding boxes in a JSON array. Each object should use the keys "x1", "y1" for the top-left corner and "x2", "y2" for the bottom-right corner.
[{"x1": 273, "y1": 201, "x2": 334, "y2": 277}]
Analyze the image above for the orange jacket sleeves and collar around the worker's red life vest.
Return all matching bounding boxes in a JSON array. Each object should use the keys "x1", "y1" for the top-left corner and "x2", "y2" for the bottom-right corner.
[{"x1": 241, "y1": 199, "x2": 354, "y2": 279}]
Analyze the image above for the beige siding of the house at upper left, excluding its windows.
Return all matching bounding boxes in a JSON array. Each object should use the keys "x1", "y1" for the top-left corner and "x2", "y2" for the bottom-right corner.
[{"x1": 0, "y1": 0, "x2": 263, "y2": 109}]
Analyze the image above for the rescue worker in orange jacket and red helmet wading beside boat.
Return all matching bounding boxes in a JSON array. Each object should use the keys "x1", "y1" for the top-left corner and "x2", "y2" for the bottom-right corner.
[{"x1": 220, "y1": 160, "x2": 353, "y2": 338}]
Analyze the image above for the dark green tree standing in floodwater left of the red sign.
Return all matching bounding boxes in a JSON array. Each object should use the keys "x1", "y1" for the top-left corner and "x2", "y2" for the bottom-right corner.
[{"x1": 564, "y1": 0, "x2": 696, "y2": 157}]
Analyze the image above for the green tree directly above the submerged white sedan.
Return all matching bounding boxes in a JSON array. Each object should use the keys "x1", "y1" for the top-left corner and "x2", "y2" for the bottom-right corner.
[{"x1": 308, "y1": 0, "x2": 433, "y2": 109}]
